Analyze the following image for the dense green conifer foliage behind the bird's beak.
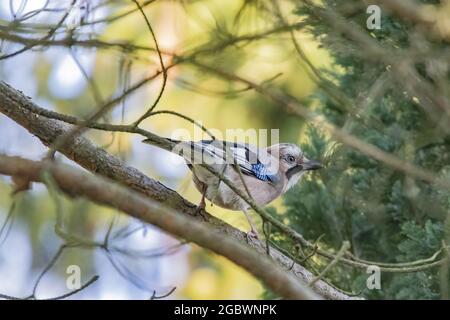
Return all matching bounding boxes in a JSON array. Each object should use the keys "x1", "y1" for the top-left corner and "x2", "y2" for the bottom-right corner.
[{"x1": 268, "y1": 0, "x2": 450, "y2": 299}]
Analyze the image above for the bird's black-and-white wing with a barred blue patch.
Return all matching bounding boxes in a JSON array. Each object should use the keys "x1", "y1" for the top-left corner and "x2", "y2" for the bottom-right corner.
[{"x1": 179, "y1": 140, "x2": 276, "y2": 181}]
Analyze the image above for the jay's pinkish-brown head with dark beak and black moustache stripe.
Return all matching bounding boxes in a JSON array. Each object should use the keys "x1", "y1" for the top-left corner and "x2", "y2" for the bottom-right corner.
[{"x1": 267, "y1": 143, "x2": 323, "y2": 190}]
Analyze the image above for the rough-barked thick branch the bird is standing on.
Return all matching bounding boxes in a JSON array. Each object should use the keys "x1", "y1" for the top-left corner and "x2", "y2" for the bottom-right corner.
[{"x1": 0, "y1": 81, "x2": 352, "y2": 300}]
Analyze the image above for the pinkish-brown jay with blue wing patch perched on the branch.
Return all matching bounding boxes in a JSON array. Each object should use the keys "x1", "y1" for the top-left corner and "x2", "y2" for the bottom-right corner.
[{"x1": 143, "y1": 139, "x2": 323, "y2": 238}]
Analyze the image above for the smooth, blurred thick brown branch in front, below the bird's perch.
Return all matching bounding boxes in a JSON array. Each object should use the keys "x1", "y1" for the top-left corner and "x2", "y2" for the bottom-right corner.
[{"x1": 0, "y1": 155, "x2": 320, "y2": 299}]
